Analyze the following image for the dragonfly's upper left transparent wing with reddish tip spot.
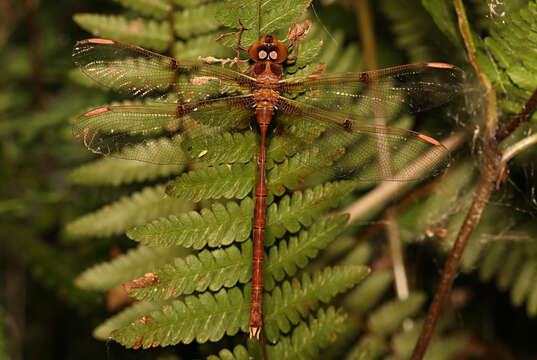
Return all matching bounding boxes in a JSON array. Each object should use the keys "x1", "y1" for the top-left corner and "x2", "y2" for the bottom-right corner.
[{"x1": 73, "y1": 39, "x2": 255, "y2": 103}]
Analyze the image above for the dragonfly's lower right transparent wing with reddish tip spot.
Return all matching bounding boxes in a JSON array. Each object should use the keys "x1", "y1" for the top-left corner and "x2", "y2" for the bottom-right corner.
[{"x1": 277, "y1": 97, "x2": 449, "y2": 181}]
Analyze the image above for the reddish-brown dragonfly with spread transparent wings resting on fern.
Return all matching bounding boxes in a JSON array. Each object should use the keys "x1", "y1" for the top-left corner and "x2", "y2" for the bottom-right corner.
[{"x1": 73, "y1": 29, "x2": 463, "y2": 339}]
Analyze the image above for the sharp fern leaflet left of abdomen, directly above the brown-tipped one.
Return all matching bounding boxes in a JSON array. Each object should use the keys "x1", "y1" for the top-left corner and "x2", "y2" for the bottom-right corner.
[{"x1": 127, "y1": 198, "x2": 254, "y2": 249}]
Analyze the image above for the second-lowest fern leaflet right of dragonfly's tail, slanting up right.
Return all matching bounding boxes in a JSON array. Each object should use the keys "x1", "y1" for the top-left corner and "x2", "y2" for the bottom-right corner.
[{"x1": 263, "y1": 266, "x2": 369, "y2": 341}]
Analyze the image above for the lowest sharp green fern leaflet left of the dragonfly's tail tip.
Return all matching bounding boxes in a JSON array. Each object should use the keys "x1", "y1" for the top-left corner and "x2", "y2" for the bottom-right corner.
[{"x1": 111, "y1": 287, "x2": 250, "y2": 349}]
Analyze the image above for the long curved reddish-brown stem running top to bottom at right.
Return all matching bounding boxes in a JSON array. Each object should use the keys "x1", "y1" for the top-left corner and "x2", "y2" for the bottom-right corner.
[{"x1": 411, "y1": 0, "x2": 500, "y2": 360}]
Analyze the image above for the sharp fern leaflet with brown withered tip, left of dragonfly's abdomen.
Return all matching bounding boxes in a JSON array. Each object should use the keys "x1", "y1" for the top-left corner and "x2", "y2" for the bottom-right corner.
[{"x1": 123, "y1": 242, "x2": 252, "y2": 301}]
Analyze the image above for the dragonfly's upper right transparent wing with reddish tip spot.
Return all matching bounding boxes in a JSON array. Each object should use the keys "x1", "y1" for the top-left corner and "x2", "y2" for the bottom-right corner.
[{"x1": 280, "y1": 63, "x2": 464, "y2": 120}]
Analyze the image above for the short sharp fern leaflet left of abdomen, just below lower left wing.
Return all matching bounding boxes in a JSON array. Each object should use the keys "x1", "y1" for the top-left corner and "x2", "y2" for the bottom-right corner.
[{"x1": 166, "y1": 163, "x2": 255, "y2": 202}]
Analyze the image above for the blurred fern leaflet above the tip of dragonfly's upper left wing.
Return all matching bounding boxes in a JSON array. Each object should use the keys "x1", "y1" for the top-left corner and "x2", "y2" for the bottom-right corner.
[{"x1": 73, "y1": 14, "x2": 170, "y2": 52}]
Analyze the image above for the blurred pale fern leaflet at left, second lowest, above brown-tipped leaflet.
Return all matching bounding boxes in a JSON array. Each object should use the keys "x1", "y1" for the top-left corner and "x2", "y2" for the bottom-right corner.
[{"x1": 75, "y1": 246, "x2": 185, "y2": 290}]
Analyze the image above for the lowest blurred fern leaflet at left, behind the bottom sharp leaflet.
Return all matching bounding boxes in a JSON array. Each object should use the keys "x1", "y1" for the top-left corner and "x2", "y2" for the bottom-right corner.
[{"x1": 93, "y1": 301, "x2": 165, "y2": 340}]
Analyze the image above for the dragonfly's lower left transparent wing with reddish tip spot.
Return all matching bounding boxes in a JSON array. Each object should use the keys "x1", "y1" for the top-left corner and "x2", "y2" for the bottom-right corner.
[{"x1": 73, "y1": 95, "x2": 254, "y2": 164}]
